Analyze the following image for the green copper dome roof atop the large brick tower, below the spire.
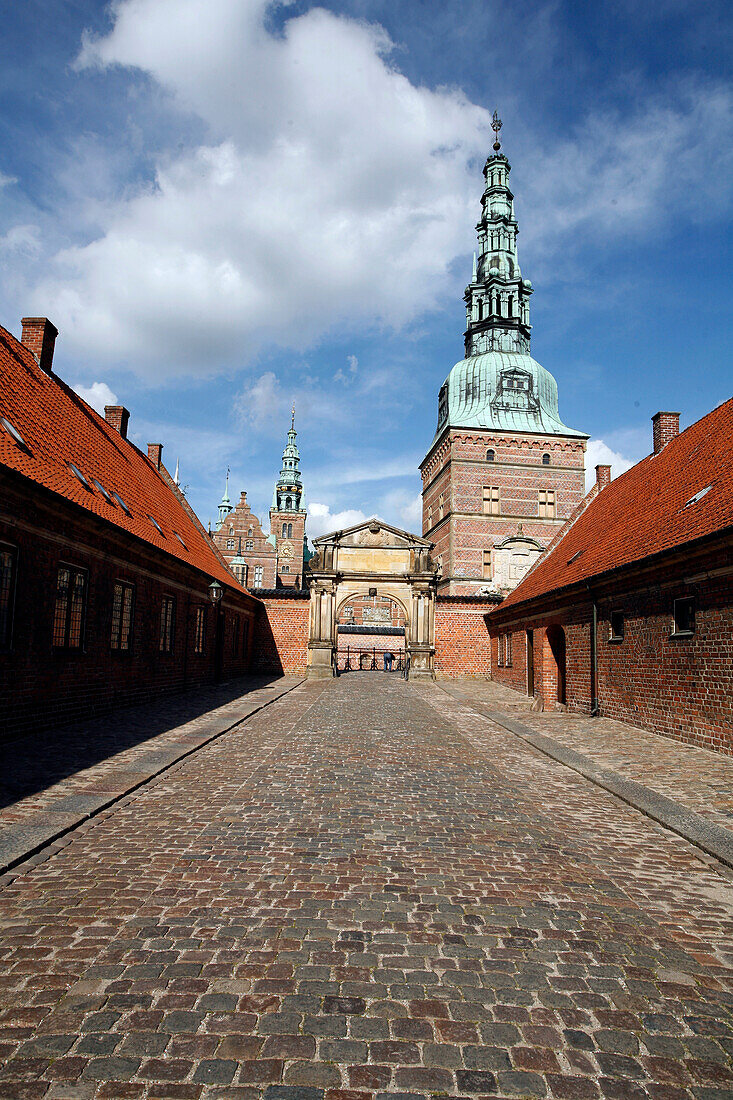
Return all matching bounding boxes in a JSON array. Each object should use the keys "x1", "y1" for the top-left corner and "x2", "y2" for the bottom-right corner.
[{"x1": 437, "y1": 351, "x2": 588, "y2": 439}]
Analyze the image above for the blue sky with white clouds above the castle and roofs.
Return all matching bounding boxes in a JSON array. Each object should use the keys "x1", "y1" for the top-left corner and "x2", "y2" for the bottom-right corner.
[{"x1": 0, "y1": 0, "x2": 733, "y2": 535}]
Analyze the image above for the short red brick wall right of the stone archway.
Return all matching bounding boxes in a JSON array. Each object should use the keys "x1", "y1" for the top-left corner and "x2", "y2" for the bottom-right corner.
[{"x1": 435, "y1": 596, "x2": 496, "y2": 680}]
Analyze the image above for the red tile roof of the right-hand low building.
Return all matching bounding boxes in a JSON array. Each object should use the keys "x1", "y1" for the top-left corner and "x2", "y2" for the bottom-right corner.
[{"x1": 497, "y1": 399, "x2": 733, "y2": 613}]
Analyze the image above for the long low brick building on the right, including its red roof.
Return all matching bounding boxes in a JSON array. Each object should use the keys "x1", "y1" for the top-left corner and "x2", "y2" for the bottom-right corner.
[{"x1": 486, "y1": 399, "x2": 733, "y2": 754}]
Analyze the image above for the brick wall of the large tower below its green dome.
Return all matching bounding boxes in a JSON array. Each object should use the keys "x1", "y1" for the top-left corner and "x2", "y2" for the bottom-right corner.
[{"x1": 420, "y1": 428, "x2": 586, "y2": 595}]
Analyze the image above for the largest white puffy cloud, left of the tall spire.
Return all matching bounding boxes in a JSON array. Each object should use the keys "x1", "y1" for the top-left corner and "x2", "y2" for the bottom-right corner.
[{"x1": 32, "y1": 0, "x2": 488, "y2": 380}]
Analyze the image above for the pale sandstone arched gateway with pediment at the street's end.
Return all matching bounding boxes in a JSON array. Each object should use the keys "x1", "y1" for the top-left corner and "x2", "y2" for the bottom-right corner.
[{"x1": 308, "y1": 517, "x2": 438, "y2": 680}]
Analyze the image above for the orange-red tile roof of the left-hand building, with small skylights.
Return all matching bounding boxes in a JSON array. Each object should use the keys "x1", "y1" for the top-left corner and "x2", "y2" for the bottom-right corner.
[{"x1": 0, "y1": 327, "x2": 254, "y2": 600}]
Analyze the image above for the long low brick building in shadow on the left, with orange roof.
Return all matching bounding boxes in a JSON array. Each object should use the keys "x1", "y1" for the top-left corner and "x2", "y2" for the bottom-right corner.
[{"x1": 0, "y1": 318, "x2": 260, "y2": 736}]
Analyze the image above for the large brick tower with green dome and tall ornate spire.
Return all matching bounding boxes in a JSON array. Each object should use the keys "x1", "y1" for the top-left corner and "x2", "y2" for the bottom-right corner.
[{"x1": 420, "y1": 112, "x2": 588, "y2": 595}]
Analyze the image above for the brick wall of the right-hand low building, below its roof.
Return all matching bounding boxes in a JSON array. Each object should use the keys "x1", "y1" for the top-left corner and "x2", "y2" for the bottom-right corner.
[{"x1": 492, "y1": 559, "x2": 733, "y2": 755}]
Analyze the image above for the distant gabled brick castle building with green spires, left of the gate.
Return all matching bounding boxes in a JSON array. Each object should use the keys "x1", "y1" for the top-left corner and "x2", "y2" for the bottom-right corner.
[{"x1": 212, "y1": 408, "x2": 310, "y2": 591}]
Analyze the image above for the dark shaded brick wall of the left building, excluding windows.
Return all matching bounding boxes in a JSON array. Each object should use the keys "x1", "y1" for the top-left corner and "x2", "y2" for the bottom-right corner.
[{"x1": 0, "y1": 477, "x2": 258, "y2": 737}]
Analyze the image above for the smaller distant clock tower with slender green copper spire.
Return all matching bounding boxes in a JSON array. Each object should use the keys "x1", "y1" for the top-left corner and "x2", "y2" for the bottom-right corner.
[{"x1": 270, "y1": 406, "x2": 310, "y2": 589}]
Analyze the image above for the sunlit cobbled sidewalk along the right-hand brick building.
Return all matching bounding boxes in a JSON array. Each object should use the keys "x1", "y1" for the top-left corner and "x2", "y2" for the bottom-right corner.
[{"x1": 441, "y1": 680, "x2": 733, "y2": 828}]
